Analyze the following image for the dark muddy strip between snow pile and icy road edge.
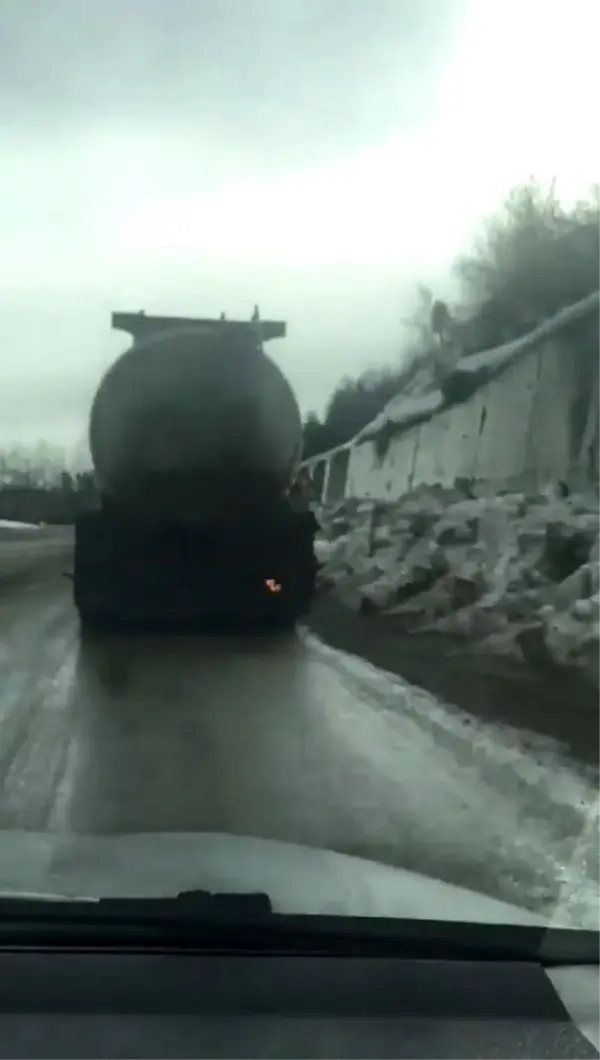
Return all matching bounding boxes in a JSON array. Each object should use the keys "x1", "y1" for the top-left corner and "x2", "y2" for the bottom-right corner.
[{"x1": 307, "y1": 591, "x2": 600, "y2": 765}]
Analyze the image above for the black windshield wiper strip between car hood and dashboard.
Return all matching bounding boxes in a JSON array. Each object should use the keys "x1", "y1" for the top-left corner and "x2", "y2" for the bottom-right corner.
[{"x1": 0, "y1": 890, "x2": 600, "y2": 966}]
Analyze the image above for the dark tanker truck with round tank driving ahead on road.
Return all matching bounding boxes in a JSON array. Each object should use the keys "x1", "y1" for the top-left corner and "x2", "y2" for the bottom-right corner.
[{"x1": 72, "y1": 314, "x2": 317, "y2": 632}]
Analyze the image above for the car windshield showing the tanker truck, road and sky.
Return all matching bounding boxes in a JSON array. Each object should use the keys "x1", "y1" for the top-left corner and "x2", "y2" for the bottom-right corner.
[{"x1": 0, "y1": 0, "x2": 600, "y2": 930}]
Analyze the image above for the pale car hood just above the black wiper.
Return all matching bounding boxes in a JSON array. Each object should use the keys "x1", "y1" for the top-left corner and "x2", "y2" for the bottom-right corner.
[{"x1": 0, "y1": 832, "x2": 548, "y2": 924}]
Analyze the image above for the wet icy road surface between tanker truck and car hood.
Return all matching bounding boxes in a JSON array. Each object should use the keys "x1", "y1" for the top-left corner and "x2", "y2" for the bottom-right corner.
[{"x1": 0, "y1": 529, "x2": 600, "y2": 926}]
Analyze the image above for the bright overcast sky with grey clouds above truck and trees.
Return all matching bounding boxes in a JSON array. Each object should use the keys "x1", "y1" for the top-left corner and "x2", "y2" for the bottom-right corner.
[{"x1": 0, "y1": 0, "x2": 600, "y2": 444}]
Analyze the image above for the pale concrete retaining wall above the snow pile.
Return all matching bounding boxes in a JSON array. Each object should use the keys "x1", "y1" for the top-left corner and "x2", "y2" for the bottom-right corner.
[{"x1": 306, "y1": 295, "x2": 600, "y2": 500}]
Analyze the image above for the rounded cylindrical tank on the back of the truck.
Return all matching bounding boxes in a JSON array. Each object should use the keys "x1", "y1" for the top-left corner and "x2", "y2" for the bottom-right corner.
[{"x1": 89, "y1": 325, "x2": 302, "y2": 522}]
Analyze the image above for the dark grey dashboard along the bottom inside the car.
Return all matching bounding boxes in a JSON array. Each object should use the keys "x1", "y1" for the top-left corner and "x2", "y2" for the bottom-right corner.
[{"x1": 0, "y1": 949, "x2": 600, "y2": 1060}]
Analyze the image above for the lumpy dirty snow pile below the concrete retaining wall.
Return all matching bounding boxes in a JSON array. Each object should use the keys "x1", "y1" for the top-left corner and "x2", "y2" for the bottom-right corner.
[{"x1": 321, "y1": 487, "x2": 600, "y2": 686}]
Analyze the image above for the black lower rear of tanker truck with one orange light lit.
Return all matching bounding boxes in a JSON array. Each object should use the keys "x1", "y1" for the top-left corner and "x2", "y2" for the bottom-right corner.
[{"x1": 73, "y1": 504, "x2": 317, "y2": 633}]
